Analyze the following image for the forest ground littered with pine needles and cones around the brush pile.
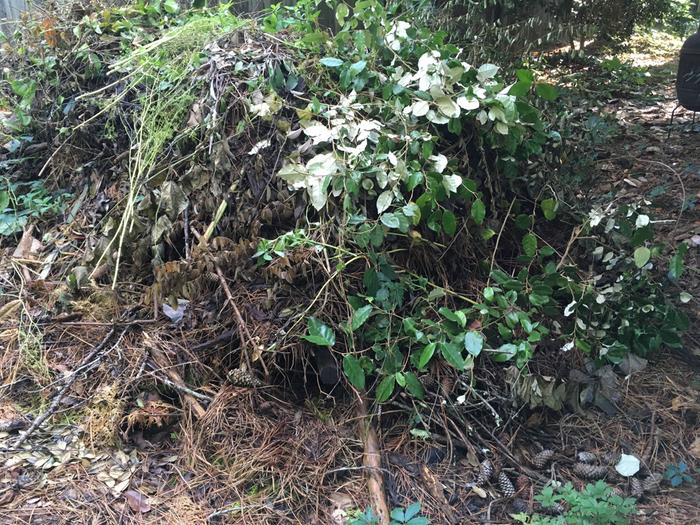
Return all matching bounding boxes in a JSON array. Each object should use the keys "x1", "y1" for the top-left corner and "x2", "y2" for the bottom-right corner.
[{"x1": 0, "y1": 30, "x2": 700, "y2": 525}]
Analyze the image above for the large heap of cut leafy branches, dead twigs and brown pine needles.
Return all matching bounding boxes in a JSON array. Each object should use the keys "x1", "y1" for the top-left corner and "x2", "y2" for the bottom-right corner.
[{"x1": 0, "y1": 1, "x2": 686, "y2": 524}]
